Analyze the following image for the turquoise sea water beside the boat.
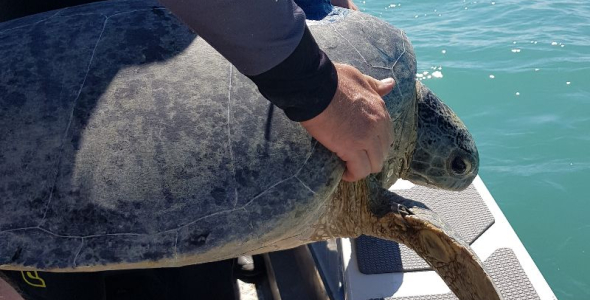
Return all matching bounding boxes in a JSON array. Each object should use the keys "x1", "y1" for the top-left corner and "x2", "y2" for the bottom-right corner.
[{"x1": 364, "y1": 0, "x2": 590, "y2": 300}]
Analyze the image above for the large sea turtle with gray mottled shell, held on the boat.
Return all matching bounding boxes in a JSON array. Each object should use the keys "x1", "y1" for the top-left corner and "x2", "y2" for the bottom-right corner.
[{"x1": 0, "y1": 0, "x2": 500, "y2": 299}]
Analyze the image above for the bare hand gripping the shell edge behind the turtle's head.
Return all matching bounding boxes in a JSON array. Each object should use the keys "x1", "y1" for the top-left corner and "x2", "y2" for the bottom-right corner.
[{"x1": 301, "y1": 64, "x2": 394, "y2": 182}]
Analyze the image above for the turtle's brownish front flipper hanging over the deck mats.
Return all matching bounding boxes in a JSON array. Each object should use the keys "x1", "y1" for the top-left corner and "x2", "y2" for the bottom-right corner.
[{"x1": 364, "y1": 180, "x2": 502, "y2": 300}]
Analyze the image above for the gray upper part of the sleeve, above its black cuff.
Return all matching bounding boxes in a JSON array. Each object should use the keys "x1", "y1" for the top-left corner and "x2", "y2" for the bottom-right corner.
[{"x1": 160, "y1": 0, "x2": 305, "y2": 76}]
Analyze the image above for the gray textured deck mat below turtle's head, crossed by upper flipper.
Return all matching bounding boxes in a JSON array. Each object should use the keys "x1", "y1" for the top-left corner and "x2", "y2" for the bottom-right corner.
[{"x1": 354, "y1": 185, "x2": 494, "y2": 274}]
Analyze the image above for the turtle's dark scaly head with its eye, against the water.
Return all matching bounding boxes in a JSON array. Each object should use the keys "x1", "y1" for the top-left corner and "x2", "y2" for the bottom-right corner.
[{"x1": 402, "y1": 81, "x2": 479, "y2": 190}]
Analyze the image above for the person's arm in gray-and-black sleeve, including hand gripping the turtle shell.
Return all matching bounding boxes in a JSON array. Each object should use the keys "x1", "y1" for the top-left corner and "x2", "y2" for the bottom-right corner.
[{"x1": 161, "y1": 0, "x2": 393, "y2": 181}]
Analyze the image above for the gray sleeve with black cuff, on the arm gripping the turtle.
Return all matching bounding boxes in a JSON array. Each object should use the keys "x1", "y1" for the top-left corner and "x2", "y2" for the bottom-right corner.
[{"x1": 160, "y1": 0, "x2": 338, "y2": 121}]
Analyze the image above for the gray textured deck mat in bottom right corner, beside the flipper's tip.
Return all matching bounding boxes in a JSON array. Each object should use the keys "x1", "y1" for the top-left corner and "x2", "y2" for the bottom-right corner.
[{"x1": 371, "y1": 248, "x2": 540, "y2": 300}]
